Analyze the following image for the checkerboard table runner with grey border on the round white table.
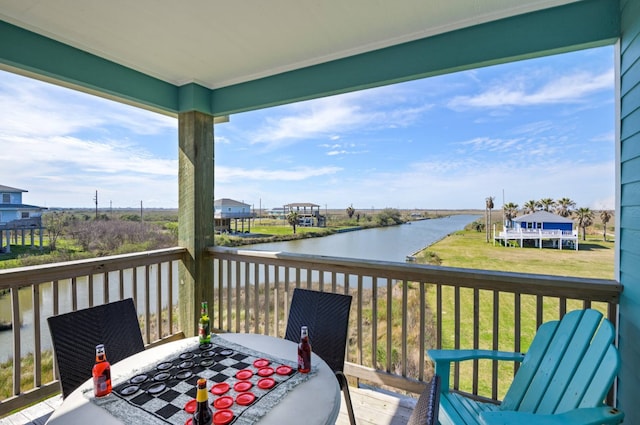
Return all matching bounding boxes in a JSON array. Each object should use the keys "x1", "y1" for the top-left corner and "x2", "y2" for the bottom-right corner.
[{"x1": 85, "y1": 336, "x2": 317, "y2": 425}]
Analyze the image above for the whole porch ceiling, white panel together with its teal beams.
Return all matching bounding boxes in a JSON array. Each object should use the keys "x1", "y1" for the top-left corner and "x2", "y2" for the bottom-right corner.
[{"x1": 0, "y1": 0, "x2": 620, "y2": 116}]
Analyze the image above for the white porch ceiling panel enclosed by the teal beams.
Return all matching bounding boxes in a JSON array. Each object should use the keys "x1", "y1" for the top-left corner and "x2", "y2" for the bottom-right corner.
[{"x1": 0, "y1": 0, "x2": 577, "y2": 89}]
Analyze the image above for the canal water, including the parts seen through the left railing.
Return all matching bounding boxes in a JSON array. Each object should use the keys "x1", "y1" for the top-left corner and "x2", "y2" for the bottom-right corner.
[{"x1": 0, "y1": 215, "x2": 479, "y2": 362}]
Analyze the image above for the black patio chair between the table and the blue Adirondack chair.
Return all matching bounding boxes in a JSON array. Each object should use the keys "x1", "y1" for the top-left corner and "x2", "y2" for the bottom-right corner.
[{"x1": 285, "y1": 288, "x2": 356, "y2": 425}]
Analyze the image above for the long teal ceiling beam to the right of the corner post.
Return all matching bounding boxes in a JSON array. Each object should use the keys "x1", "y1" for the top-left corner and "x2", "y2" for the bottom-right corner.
[{"x1": 213, "y1": 0, "x2": 620, "y2": 115}]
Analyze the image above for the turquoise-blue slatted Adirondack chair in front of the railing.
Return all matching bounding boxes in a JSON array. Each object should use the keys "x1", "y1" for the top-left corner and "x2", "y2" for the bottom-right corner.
[{"x1": 428, "y1": 309, "x2": 624, "y2": 425}]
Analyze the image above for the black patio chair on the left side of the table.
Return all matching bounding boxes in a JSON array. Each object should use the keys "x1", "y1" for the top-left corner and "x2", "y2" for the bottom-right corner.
[{"x1": 47, "y1": 298, "x2": 144, "y2": 398}]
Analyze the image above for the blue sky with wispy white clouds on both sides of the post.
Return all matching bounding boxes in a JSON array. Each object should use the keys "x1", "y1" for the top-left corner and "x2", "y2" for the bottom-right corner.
[{"x1": 0, "y1": 47, "x2": 615, "y2": 210}]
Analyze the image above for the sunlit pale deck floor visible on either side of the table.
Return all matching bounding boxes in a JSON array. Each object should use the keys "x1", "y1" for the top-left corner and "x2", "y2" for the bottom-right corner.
[{"x1": 0, "y1": 387, "x2": 416, "y2": 425}]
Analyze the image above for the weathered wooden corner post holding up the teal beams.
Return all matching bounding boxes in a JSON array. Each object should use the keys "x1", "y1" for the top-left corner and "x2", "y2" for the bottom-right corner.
[{"x1": 178, "y1": 111, "x2": 214, "y2": 336}]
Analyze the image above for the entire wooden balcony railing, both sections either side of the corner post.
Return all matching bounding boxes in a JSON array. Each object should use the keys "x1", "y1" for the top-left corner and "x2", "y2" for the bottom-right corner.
[{"x1": 0, "y1": 247, "x2": 622, "y2": 417}]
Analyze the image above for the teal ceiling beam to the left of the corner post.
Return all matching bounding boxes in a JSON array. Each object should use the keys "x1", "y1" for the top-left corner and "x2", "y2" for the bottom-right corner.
[{"x1": 0, "y1": 21, "x2": 179, "y2": 114}]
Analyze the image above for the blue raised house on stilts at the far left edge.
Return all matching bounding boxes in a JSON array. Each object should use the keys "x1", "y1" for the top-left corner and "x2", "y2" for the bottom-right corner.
[{"x1": 0, "y1": 185, "x2": 46, "y2": 252}]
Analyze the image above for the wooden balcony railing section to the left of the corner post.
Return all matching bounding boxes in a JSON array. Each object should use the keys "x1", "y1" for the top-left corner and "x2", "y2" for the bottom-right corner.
[{"x1": 0, "y1": 248, "x2": 185, "y2": 417}]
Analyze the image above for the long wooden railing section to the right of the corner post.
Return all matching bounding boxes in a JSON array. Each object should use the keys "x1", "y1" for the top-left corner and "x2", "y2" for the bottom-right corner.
[{"x1": 209, "y1": 247, "x2": 622, "y2": 400}]
